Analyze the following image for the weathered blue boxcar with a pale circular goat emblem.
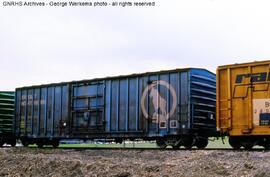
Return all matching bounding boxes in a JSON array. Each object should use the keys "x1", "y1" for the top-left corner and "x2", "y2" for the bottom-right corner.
[{"x1": 16, "y1": 68, "x2": 216, "y2": 148}]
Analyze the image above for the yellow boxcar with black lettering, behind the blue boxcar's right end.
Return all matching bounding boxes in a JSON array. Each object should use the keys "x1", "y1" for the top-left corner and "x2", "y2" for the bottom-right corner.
[{"x1": 216, "y1": 60, "x2": 270, "y2": 149}]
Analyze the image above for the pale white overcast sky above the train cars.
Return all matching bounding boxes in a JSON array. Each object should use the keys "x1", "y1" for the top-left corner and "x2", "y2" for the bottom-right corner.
[{"x1": 0, "y1": 0, "x2": 270, "y2": 90}]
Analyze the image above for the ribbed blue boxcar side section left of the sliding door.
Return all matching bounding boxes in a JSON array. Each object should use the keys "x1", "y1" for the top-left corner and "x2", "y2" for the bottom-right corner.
[{"x1": 15, "y1": 84, "x2": 70, "y2": 137}]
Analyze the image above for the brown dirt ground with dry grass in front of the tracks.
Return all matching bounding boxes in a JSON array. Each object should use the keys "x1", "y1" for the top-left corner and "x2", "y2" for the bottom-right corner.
[{"x1": 0, "y1": 147, "x2": 270, "y2": 177}]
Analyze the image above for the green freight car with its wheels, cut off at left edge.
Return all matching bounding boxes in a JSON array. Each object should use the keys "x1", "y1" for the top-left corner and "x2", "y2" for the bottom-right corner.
[{"x1": 0, "y1": 91, "x2": 16, "y2": 147}]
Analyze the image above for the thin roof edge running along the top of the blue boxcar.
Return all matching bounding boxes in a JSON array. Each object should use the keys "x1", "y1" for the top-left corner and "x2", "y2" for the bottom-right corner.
[{"x1": 16, "y1": 67, "x2": 214, "y2": 90}]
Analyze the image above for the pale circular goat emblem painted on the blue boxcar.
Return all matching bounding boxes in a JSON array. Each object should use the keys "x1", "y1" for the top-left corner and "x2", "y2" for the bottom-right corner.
[{"x1": 141, "y1": 80, "x2": 177, "y2": 119}]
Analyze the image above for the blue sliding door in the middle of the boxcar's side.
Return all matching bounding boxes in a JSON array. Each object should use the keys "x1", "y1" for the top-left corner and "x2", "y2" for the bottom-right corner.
[{"x1": 71, "y1": 81, "x2": 105, "y2": 135}]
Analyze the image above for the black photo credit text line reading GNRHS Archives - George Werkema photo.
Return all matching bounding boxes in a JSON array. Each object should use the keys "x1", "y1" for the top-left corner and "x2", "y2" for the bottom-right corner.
[{"x1": 1, "y1": 0, "x2": 156, "y2": 7}]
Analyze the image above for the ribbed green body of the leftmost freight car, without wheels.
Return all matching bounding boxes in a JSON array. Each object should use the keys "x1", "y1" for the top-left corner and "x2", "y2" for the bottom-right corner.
[{"x1": 0, "y1": 92, "x2": 15, "y2": 134}]
